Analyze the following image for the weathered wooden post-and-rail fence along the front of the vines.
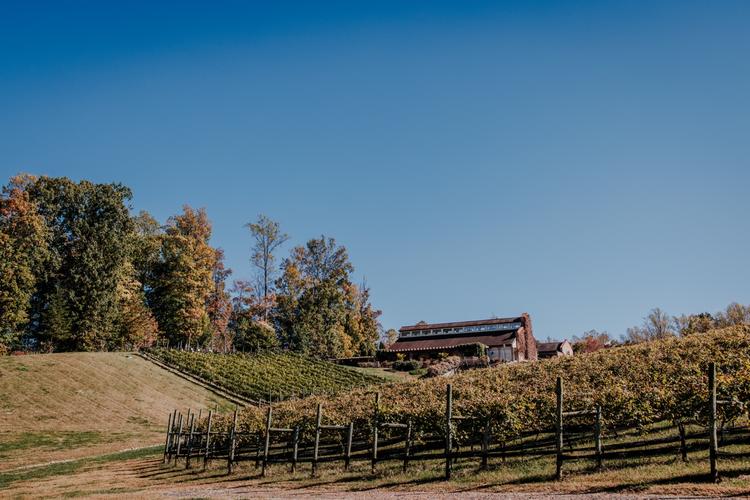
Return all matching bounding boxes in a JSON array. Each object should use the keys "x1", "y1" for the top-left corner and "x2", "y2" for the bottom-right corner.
[{"x1": 164, "y1": 363, "x2": 750, "y2": 481}]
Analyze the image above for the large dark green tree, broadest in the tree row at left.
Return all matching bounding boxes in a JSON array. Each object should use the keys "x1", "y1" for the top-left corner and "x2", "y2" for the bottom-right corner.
[{"x1": 29, "y1": 177, "x2": 133, "y2": 351}]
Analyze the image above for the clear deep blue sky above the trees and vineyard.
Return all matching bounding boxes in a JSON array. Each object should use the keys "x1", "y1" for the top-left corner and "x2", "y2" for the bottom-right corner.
[{"x1": 0, "y1": 0, "x2": 750, "y2": 338}]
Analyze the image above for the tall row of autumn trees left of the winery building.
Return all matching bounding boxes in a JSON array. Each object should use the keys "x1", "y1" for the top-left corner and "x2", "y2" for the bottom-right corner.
[{"x1": 0, "y1": 174, "x2": 380, "y2": 357}]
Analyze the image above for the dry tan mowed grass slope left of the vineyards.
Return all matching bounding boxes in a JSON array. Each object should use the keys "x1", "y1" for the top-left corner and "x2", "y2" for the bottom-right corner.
[{"x1": 0, "y1": 353, "x2": 230, "y2": 471}]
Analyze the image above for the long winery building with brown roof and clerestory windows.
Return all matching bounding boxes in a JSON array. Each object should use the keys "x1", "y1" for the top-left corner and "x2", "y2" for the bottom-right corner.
[{"x1": 388, "y1": 313, "x2": 537, "y2": 361}]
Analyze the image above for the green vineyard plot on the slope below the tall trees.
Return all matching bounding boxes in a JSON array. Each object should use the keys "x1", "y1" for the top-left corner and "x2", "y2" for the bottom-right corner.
[{"x1": 149, "y1": 349, "x2": 386, "y2": 401}]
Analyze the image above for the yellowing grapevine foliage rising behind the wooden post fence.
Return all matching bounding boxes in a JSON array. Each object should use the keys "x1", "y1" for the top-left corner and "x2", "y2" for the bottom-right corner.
[{"x1": 212, "y1": 326, "x2": 750, "y2": 439}]
